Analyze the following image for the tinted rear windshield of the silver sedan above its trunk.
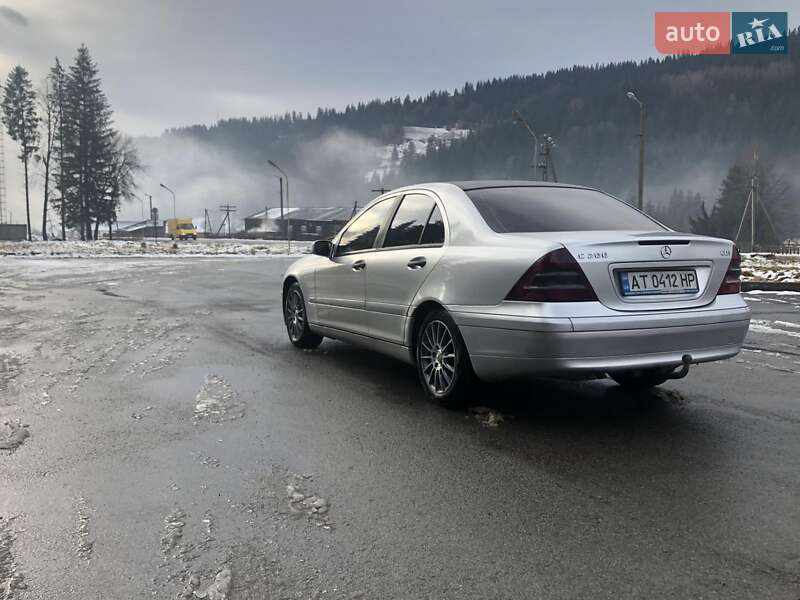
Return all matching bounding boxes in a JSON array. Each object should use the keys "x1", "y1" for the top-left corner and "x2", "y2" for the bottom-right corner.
[{"x1": 466, "y1": 186, "x2": 664, "y2": 233}]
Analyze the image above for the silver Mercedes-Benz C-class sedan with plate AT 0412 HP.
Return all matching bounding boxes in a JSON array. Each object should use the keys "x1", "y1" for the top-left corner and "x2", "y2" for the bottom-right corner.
[{"x1": 283, "y1": 181, "x2": 750, "y2": 404}]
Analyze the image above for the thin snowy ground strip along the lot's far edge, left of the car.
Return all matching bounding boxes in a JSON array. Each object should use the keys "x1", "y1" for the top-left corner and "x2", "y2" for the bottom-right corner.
[{"x1": 0, "y1": 239, "x2": 311, "y2": 258}]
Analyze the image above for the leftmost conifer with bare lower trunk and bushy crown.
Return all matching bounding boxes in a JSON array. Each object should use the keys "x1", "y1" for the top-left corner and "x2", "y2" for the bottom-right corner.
[{"x1": 2, "y1": 65, "x2": 39, "y2": 241}]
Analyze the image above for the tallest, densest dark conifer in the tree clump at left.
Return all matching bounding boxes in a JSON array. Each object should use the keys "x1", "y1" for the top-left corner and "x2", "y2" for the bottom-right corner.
[{"x1": 63, "y1": 45, "x2": 114, "y2": 240}]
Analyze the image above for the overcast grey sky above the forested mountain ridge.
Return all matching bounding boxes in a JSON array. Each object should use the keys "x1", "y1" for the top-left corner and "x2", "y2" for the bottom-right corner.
[{"x1": 0, "y1": 0, "x2": 795, "y2": 135}]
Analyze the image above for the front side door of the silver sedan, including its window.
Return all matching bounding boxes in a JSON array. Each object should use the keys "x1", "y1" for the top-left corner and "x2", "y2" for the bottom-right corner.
[{"x1": 313, "y1": 198, "x2": 396, "y2": 335}]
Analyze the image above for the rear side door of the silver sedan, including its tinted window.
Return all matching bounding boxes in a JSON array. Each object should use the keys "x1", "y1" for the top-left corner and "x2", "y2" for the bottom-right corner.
[{"x1": 366, "y1": 192, "x2": 445, "y2": 344}]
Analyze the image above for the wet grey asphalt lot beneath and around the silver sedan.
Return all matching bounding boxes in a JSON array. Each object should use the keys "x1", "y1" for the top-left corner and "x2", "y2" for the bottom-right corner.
[{"x1": 0, "y1": 258, "x2": 800, "y2": 600}]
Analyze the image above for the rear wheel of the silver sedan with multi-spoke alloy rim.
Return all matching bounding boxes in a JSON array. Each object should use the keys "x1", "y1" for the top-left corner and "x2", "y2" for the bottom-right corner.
[{"x1": 415, "y1": 310, "x2": 476, "y2": 408}]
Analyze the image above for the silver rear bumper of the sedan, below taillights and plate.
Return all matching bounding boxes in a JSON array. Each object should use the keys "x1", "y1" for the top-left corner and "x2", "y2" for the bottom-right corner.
[{"x1": 451, "y1": 302, "x2": 750, "y2": 379}]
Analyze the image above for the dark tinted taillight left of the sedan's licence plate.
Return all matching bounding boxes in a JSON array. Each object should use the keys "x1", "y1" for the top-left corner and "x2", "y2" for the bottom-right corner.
[{"x1": 506, "y1": 248, "x2": 597, "y2": 302}]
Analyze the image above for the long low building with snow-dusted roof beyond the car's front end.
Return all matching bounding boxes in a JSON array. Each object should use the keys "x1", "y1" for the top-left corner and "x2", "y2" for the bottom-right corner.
[{"x1": 244, "y1": 206, "x2": 353, "y2": 240}]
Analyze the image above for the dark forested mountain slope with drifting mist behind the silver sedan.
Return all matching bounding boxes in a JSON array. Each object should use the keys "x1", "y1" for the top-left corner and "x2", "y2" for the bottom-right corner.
[{"x1": 155, "y1": 31, "x2": 800, "y2": 231}]
